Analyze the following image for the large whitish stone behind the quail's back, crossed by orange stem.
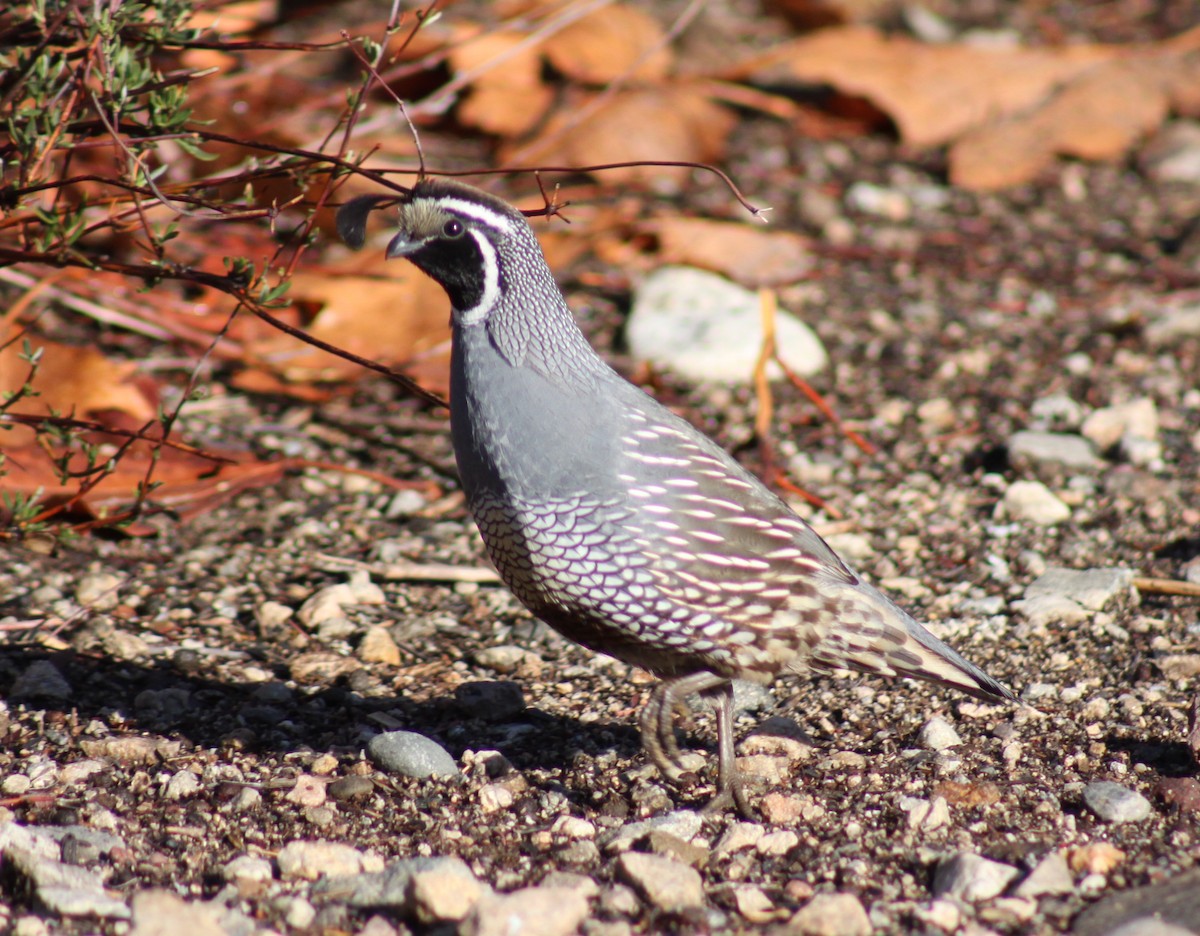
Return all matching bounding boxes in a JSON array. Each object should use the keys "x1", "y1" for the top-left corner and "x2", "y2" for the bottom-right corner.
[{"x1": 626, "y1": 266, "x2": 828, "y2": 384}]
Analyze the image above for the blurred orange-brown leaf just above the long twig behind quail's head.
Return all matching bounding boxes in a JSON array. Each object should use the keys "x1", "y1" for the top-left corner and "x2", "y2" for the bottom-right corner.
[{"x1": 502, "y1": 84, "x2": 736, "y2": 185}]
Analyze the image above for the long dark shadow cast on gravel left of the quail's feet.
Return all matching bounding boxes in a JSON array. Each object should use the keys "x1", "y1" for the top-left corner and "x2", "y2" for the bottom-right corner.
[{"x1": 0, "y1": 646, "x2": 641, "y2": 769}]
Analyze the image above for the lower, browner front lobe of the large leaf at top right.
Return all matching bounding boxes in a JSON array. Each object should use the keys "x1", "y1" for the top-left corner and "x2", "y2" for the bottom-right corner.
[{"x1": 949, "y1": 59, "x2": 1169, "y2": 191}]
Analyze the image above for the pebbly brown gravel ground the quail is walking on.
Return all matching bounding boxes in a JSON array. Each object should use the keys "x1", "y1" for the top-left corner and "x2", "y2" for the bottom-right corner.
[{"x1": 0, "y1": 20, "x2": 1200, "y2": 936}]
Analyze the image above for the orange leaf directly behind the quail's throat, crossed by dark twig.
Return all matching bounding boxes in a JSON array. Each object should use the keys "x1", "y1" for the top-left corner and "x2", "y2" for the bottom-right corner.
[{"x1": 238, "y1": 264, "x2": 450, "y2": 383}]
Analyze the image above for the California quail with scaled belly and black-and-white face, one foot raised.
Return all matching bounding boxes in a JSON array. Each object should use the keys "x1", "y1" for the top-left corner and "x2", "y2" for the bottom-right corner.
[{"x1": 340, "y1": 179, "x2": 1014, "y2": 814}]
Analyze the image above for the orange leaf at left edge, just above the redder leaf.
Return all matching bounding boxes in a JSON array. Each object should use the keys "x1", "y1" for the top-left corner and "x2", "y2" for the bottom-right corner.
[{"x1": 0, "y1": 325, "x2": 158, "y2": 448}]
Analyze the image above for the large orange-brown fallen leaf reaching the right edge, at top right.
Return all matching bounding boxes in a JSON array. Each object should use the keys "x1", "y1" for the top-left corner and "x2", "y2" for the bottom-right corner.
[{"x1": 730, "y1": 26, "x2": 1200, "y2": 190}]
